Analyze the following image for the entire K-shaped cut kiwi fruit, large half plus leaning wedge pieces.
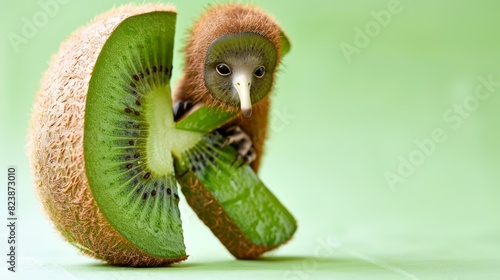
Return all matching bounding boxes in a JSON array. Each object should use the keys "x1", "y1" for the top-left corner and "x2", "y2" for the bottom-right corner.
[{"x1": 29, "y1": 4, "x2": 296, "y2": 266}]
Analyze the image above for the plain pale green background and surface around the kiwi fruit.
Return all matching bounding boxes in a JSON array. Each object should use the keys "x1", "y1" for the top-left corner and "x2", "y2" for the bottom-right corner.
[{"x1": 0, "y1": 0, "x2": 500, "y2": 279}]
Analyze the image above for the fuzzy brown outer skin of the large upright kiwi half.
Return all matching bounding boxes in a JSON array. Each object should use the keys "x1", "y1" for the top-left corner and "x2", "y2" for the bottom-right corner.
[{"x1": 28, "y1": 4, "x2": 187, "y2": 266}]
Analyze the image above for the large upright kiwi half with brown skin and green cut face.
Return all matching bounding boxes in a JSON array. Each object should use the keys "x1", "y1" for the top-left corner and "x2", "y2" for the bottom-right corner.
[{"x1": 30, "y1": 4, "x2": 189, "y2": 266}]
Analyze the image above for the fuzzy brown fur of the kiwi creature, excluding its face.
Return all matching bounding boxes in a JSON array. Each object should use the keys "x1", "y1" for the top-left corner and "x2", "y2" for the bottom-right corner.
[{"x1": 173, "y1": 4, "x2": 281, "y2": 171}]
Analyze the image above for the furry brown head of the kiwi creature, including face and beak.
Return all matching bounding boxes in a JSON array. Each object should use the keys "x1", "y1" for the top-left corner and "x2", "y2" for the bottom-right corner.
[{"x1": 182, "y1": 3, "x2": 289, "y2": 117}]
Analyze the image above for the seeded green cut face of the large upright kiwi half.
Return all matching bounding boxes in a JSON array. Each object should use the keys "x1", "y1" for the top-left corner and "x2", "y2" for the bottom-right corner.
[{"x1": 84, "y1": 12, "x2": 198, "y2": 258}]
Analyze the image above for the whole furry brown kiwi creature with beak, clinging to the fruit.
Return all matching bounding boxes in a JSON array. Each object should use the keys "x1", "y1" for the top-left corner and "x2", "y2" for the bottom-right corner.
[{"x1": 173, "y1": 4, "x2": 281, "y2": 171}]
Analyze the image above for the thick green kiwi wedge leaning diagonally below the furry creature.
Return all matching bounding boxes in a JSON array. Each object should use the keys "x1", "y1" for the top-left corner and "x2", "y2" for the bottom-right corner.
[{"x1": 175, "y1": 133, "x2": 297, "y2": 259}]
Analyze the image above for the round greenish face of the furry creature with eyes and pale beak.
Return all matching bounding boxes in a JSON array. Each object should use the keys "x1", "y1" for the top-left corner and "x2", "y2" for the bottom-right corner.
[{"x1": 204, "y1": 32, "x2": 278, "y2": 118}]
